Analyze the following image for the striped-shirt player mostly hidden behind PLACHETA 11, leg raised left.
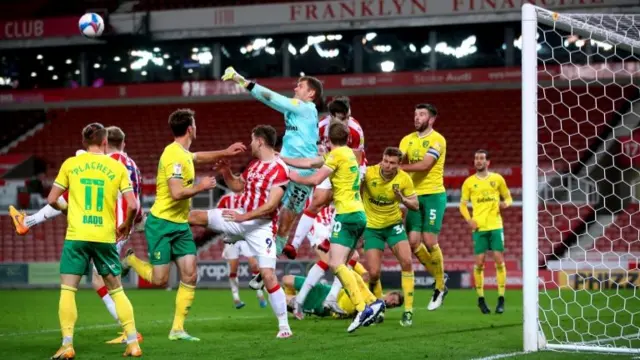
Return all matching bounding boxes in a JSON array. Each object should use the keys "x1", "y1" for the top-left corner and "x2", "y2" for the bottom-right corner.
[{"x1": 9, "y1": 126, "x2": 144, "y2": 344}]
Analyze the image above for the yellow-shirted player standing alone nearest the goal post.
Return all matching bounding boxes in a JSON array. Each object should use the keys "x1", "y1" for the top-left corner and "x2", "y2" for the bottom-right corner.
[{"x1": 460, "y1": 150, "x2": 513, "y2": 314}]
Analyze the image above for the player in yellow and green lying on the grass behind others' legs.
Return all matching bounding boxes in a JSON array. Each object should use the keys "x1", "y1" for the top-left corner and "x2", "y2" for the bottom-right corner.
[{"x1": 282, "y1": 274, "x2": 404, "y2": 321}]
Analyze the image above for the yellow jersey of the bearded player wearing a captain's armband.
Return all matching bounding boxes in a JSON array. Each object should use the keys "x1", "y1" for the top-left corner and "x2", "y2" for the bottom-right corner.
[{"x1": 400, "y1": 130, "x2": 447, "y2": 195}]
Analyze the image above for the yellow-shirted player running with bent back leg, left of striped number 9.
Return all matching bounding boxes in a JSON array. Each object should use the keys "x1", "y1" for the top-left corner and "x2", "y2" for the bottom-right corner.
[{"x1": 122, "y1": 109, "x2": 245, "y2": 341}]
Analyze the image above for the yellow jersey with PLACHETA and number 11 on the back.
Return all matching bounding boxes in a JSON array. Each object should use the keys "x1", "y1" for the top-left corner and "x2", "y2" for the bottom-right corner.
[{"x1": 54, "y1": 152, "x2": 133, "y2": 243}]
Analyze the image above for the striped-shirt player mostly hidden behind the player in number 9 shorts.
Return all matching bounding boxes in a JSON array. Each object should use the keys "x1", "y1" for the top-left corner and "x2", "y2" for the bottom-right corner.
[{"x1": 216, "y1": 193, "x2": 267, "y2": 309}]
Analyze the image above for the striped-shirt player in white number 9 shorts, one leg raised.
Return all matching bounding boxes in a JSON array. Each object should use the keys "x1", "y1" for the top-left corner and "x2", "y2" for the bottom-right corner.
[{"x1": 189, "y1": 125, "x2": 293, "y2": 338}]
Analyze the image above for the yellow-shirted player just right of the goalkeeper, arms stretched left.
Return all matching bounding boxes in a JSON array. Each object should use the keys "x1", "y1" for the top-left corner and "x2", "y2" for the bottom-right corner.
[{"x1": 283, "y1": 122, "x2": 384, "y2": 332}]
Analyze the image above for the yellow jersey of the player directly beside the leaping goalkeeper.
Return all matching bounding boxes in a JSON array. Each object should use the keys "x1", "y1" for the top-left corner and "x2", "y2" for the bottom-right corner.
[{"x1": 324, "y1": 146, "x2": 364, "y2": 214}]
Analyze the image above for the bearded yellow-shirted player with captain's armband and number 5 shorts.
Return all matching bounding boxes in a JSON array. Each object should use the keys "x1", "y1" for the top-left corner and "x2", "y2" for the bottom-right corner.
[{"x1": 400, "y1": 104, "x2": 447, "y2": 310}]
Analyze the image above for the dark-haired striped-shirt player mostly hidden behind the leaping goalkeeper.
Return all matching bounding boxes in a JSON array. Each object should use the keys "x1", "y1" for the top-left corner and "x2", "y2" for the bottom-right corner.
[{"x1": 283, "y1": 97, "x2": 367, "y2": 259}]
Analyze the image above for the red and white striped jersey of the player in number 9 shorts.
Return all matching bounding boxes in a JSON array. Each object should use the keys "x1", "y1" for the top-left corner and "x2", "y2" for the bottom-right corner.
[{"x1": 238, "y1": 158, "x2": 289, "y2": 219}]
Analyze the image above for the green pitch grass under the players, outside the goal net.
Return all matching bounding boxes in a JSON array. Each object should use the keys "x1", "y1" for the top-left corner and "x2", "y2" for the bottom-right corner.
[{"x1": 0, "y1": 289, "x2": 631, "y2": 360}]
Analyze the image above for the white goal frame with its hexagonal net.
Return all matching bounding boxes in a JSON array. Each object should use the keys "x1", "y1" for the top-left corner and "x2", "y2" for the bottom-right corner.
[{"x1": 522, "y1": 4, "x2": 640, "y2": 354}]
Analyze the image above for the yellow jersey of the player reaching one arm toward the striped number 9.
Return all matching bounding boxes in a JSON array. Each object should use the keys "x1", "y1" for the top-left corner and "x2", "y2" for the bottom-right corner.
[{"x1": 151, "y1": 142, "x2": 196, "y2": 223}]
